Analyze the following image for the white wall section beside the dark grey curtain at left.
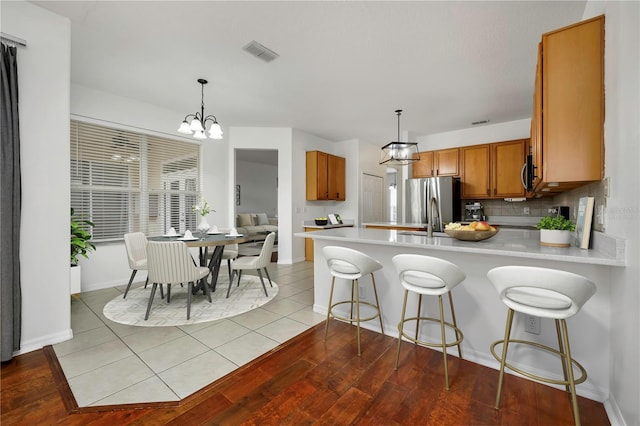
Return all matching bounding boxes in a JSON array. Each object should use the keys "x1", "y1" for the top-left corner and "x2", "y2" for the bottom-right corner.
[{"x1": 1, "y1": 1, "x2": 72, "y2": 353}]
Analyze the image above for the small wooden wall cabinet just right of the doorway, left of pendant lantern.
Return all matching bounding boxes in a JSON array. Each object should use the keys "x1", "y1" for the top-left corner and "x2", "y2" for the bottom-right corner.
[{"x1": 307, "y1": 151, "x2": 346, "y2": 201}]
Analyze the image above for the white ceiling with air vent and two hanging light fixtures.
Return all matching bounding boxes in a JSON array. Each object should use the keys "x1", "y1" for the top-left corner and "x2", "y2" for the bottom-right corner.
[{"x1": 33, "y1": 1, "x2": 585, "y2": 145}]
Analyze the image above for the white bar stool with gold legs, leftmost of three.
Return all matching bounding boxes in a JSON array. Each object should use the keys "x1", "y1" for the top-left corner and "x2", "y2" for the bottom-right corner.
[{"x1": 322, "y1": 246, "x2": 384, "y2": 356}]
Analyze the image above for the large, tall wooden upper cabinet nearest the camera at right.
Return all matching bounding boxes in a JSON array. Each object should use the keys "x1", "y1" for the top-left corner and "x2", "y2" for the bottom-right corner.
[{"x1": 531, "y1": 16, "x2": 604, "y2": 194}]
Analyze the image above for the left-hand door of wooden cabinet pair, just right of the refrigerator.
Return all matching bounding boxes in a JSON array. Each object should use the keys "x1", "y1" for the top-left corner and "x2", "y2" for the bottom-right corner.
[{"x1": 460, "y1": 144, "x2": 491, "y2": 198}]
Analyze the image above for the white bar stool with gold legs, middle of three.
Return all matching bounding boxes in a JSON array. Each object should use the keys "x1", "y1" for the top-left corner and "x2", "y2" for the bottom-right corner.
[{"x1": 392, "y1": 254, "x2": 466, "y2": 390}]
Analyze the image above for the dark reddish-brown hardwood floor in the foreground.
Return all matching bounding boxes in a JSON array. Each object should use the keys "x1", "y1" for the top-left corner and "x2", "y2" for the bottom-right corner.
[{"x1": 0, "y1": 320, "x2": 609, "y2": 426}]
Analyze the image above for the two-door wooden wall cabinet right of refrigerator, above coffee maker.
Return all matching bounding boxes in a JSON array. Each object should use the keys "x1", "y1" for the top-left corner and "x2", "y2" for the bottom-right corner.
[{"x1": 460, "y1": 139, "x2": 528, "y2": 199}]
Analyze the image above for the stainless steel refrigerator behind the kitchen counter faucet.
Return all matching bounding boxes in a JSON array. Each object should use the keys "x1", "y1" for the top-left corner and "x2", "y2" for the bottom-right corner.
[{"x1": 405, "y1": 176, "x2": 462, "y2": 232}]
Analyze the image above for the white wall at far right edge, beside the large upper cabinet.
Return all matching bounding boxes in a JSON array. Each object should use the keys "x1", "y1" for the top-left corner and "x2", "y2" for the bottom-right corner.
[{"x1": 583, "y1": 1, "x2": 640, "y2": 425}]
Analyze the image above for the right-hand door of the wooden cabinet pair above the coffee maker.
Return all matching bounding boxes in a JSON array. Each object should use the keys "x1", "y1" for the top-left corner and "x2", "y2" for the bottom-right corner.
[{"x1": 491, "y1": 140, "x2": 527, "y2": 198}]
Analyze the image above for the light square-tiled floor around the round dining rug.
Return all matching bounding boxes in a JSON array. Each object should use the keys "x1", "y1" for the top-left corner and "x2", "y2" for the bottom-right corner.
[{"x1": 54, "y1": 262, "x2": 325, "y2": 407}]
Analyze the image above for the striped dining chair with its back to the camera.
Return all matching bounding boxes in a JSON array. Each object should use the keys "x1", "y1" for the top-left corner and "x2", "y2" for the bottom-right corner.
[{"x1": 144, "y1": 241, "x2": 211, "y2": 320}]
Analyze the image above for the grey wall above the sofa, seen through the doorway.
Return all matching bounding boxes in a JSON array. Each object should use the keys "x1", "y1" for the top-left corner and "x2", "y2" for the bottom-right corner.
[{"x1": 236, "y1": 160, "x2": 278, "y2": 217}]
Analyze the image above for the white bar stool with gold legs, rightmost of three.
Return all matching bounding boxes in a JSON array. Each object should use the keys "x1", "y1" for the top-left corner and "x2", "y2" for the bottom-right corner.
[{"x1": 487, "y1": 266, "x2": 596, "y2": 425}]
